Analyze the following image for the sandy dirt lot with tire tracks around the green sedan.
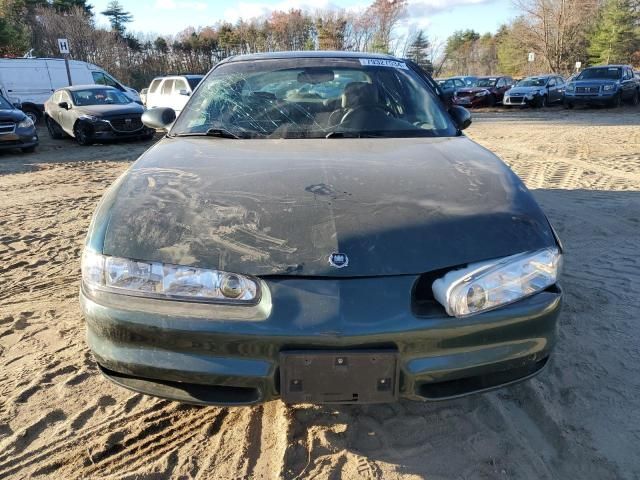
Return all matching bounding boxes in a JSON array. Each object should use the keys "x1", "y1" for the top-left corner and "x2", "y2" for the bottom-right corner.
[{"x1": 0, "y1": 107, "x2": 640, "y2": 479}]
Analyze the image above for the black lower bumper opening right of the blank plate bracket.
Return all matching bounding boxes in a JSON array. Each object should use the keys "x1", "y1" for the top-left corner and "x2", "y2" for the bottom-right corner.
[{"x1": 416, "y1": 357, "x2": 549, "y2": 400}]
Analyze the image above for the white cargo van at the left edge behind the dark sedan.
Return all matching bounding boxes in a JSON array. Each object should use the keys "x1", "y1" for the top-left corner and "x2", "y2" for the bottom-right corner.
[{"x1": 0, "y1": 58, "x2": 140, "y2": 122}]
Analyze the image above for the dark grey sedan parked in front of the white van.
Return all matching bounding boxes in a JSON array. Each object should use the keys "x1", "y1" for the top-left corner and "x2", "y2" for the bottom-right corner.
[{"x1": 44, "y1": 85, "x2": 155, "y2": 145}]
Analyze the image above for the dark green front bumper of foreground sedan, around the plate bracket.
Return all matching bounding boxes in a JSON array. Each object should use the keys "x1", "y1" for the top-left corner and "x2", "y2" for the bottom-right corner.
[{"x1": 80, "y1": 276, "x2": 562, "y2": 405}]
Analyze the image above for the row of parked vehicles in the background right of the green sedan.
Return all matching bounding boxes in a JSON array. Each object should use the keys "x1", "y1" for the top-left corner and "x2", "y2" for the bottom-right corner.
[{"x1": 438, "y1": 65, "x2": 640, "y2": 108}]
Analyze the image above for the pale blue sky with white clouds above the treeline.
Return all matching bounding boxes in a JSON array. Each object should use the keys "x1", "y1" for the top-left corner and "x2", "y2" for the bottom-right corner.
[{"x1": 89, "y1": 0, "x2": 516, "y2": 45}]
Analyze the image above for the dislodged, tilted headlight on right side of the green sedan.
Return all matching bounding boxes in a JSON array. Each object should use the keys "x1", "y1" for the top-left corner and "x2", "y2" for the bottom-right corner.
[{"x1": 432, "y1": 248, "x2": 562, "y2": 317}]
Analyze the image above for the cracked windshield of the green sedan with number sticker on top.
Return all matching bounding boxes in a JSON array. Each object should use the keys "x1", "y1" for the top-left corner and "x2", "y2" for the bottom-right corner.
[{"x1": 169, "y1": 56, "x2": 457, "y2": 139}]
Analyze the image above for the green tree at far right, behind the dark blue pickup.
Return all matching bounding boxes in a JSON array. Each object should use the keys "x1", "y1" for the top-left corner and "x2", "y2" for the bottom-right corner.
[{"x1": 588, "y1": 0, "x2": 640, "y2": 64}]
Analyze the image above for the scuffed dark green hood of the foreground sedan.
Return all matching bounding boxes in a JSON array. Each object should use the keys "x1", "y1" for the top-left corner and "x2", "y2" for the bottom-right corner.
[{"x1": 96, "y1": 136, "x2": 555, "y2": 276}]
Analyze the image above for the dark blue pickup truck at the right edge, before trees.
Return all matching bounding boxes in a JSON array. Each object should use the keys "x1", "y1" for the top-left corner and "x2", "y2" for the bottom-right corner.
[{"x1": 564, "y1": 65, "x2": 640, "y2": 108}]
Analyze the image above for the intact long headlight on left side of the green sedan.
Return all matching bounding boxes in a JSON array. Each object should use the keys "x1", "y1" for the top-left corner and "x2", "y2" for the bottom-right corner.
[{"x1": 82, "y1": 249, "x2": 259, "y2": 303}]
